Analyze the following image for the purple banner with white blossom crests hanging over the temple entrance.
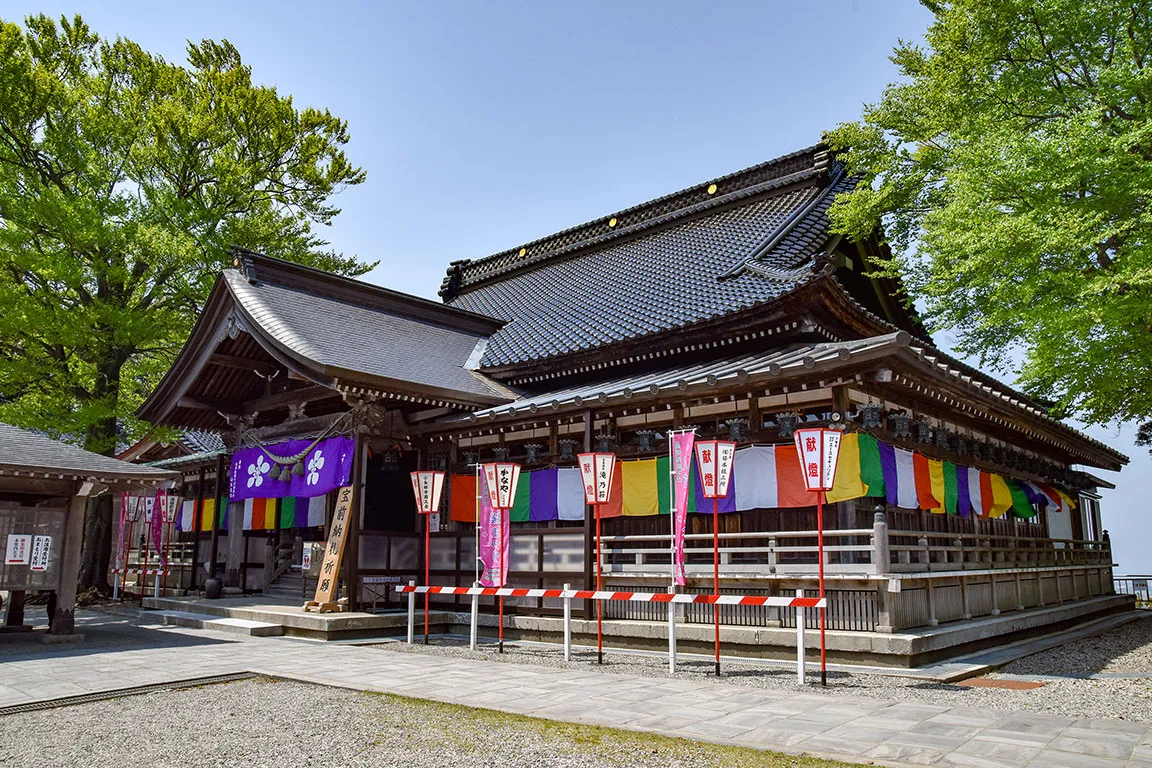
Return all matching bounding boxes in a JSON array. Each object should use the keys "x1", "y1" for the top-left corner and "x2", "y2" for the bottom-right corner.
[{"x1": 228, "y1": 438, "x2": 355, "y2": 501}]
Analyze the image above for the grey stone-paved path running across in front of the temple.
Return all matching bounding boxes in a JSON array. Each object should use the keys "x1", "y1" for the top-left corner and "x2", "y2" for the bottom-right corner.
[{"x1": 0, "y1": 615, "x2": 1152, "y2": 768}]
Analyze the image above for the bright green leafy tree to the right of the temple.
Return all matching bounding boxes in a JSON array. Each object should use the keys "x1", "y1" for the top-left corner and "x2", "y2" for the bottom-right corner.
[{"x1": 827, "y1": 0, "x2": 1152, "y2": 437}]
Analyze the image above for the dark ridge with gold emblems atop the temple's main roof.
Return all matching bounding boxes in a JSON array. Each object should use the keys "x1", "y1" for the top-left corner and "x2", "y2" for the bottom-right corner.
[{"x1": 439, "y1": 143, "x2": 832, "y2": 302}]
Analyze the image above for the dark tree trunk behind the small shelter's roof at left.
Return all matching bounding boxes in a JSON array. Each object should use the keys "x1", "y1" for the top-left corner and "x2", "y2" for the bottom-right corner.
[{"x1": 76, "y1": 350, "x2": 127, "y2": 594}]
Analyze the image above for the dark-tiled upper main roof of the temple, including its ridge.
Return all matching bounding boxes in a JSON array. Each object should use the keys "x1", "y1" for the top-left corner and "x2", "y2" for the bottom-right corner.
[{"x1": 441, "y1": 147, "x2": 852, "y2": 367}]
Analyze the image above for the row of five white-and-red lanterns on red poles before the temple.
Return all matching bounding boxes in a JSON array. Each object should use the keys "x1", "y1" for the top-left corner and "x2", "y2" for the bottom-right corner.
[{"x1": 411, "y1": 427, "x2": 841, "y2": 684}]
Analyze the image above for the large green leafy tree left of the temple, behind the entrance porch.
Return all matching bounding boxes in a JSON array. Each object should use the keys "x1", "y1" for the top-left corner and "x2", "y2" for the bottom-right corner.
[{"x1": 0, "y1": 15, "x2": 371, "y2": 586}]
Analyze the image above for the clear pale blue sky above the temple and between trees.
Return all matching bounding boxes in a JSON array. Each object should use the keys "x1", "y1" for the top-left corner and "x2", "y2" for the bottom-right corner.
[{"x1": 11, "y1": 0, "x2": 1152, "y2": 573}]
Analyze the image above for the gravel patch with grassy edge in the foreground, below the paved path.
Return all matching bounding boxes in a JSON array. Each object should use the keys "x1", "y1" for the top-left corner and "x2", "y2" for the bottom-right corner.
[{"x1": 0, "y1": 680, "x2": 847, "y2": 768}]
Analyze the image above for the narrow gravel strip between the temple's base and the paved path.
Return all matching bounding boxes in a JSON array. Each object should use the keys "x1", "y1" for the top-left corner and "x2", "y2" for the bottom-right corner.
[{"x1": 372, "y1": 622, "x2": 1152, "y2": 723}]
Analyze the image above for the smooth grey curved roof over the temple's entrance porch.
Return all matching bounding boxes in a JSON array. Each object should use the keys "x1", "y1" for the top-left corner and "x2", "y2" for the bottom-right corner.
[{"x1": 223, "y1": 269, "x2": 515, "y2": 402}]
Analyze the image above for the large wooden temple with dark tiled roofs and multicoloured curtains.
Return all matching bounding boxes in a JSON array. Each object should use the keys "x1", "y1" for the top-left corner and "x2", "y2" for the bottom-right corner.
[{"x1": 129, "y1": 146, "x2": 1129, "y2": 663}]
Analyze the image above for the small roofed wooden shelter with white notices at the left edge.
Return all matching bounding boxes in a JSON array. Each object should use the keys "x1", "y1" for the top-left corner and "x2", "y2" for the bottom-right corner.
[{"x1": 0, "y1": 424, "x2": 180, "y2": 636}]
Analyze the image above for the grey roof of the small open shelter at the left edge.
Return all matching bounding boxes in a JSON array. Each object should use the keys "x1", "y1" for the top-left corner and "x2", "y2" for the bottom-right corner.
[{"x1": 0, "y1": 424, "x2": 177, "y2": 482}]
